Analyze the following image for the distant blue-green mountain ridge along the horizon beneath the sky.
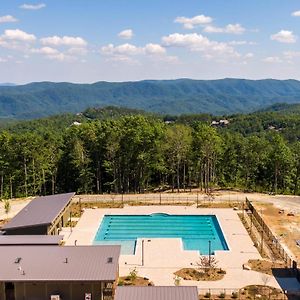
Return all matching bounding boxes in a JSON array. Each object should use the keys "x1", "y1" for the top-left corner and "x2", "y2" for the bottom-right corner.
[{"x1": 0, "y1": 79, "x2": 300, "y2": 119}]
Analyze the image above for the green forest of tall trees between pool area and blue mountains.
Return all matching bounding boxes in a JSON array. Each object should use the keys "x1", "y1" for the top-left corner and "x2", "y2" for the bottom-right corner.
[{"x1": 0, "y1": 104, "x2": 300, "y2": 199}]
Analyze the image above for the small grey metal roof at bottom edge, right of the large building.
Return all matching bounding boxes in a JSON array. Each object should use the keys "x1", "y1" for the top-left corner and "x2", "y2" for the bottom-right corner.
[{"x1": 115, "y1": 286, "x2": 198, "y2": 300}]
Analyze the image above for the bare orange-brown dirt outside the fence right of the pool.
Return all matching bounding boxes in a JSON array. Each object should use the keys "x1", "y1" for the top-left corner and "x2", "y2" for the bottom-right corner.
[{"x1": 253, "y1": 202, "x2": 300, "y2": 261}]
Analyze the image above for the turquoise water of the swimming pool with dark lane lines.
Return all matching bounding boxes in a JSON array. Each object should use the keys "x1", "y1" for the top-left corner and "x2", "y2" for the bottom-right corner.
[{"x1": 94, "y1": 213, "x2": 228, "y2": 255}]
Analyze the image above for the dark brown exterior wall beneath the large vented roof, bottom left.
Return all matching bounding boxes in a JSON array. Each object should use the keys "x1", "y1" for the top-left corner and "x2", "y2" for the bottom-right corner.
[{"x1": 0, "y1": 282, "x2": 113, "y2": 300}]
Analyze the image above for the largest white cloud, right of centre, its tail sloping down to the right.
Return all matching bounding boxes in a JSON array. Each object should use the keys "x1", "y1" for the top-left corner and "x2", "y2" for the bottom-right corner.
[{"x1": 162, "y1": 33, "x2": 240, "y2": 58}]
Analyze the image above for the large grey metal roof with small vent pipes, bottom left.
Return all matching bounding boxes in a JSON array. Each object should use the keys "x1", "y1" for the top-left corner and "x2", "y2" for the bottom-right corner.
[{"x1": 0, "y1": 246, "x2": 120, "y2": 282}]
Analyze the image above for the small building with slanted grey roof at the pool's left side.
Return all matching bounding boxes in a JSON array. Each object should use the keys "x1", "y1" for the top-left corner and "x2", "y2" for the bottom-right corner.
[{"x1": 1, "y1": 193, "x2": 75, "y2": 235}]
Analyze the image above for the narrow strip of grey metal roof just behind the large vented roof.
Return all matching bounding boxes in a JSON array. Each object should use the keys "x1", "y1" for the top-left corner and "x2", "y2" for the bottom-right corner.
[{"x1": 0, "y1": 235, "x2": 63, "y2": 246}]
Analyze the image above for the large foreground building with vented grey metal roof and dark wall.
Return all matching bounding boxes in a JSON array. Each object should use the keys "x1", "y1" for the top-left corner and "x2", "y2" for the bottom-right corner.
[{"x1": 0, "y1": 246, "x2": 120, "y2": 300}]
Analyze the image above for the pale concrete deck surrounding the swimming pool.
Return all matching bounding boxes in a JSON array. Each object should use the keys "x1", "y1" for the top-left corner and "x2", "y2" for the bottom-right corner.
[{"x1": 62, "y1": 206, "x2": 299, "y2": 290}]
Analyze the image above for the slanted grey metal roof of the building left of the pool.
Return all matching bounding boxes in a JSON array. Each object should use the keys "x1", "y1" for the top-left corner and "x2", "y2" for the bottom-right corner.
[{"x1": 2, "y1": 193, "x2": 75, "y2": 230}]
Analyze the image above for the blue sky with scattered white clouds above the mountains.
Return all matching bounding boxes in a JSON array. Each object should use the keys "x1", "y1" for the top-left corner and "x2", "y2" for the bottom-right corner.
[{"x1": 0, "y1": 0, "x2": 300, "y2": 83}]
